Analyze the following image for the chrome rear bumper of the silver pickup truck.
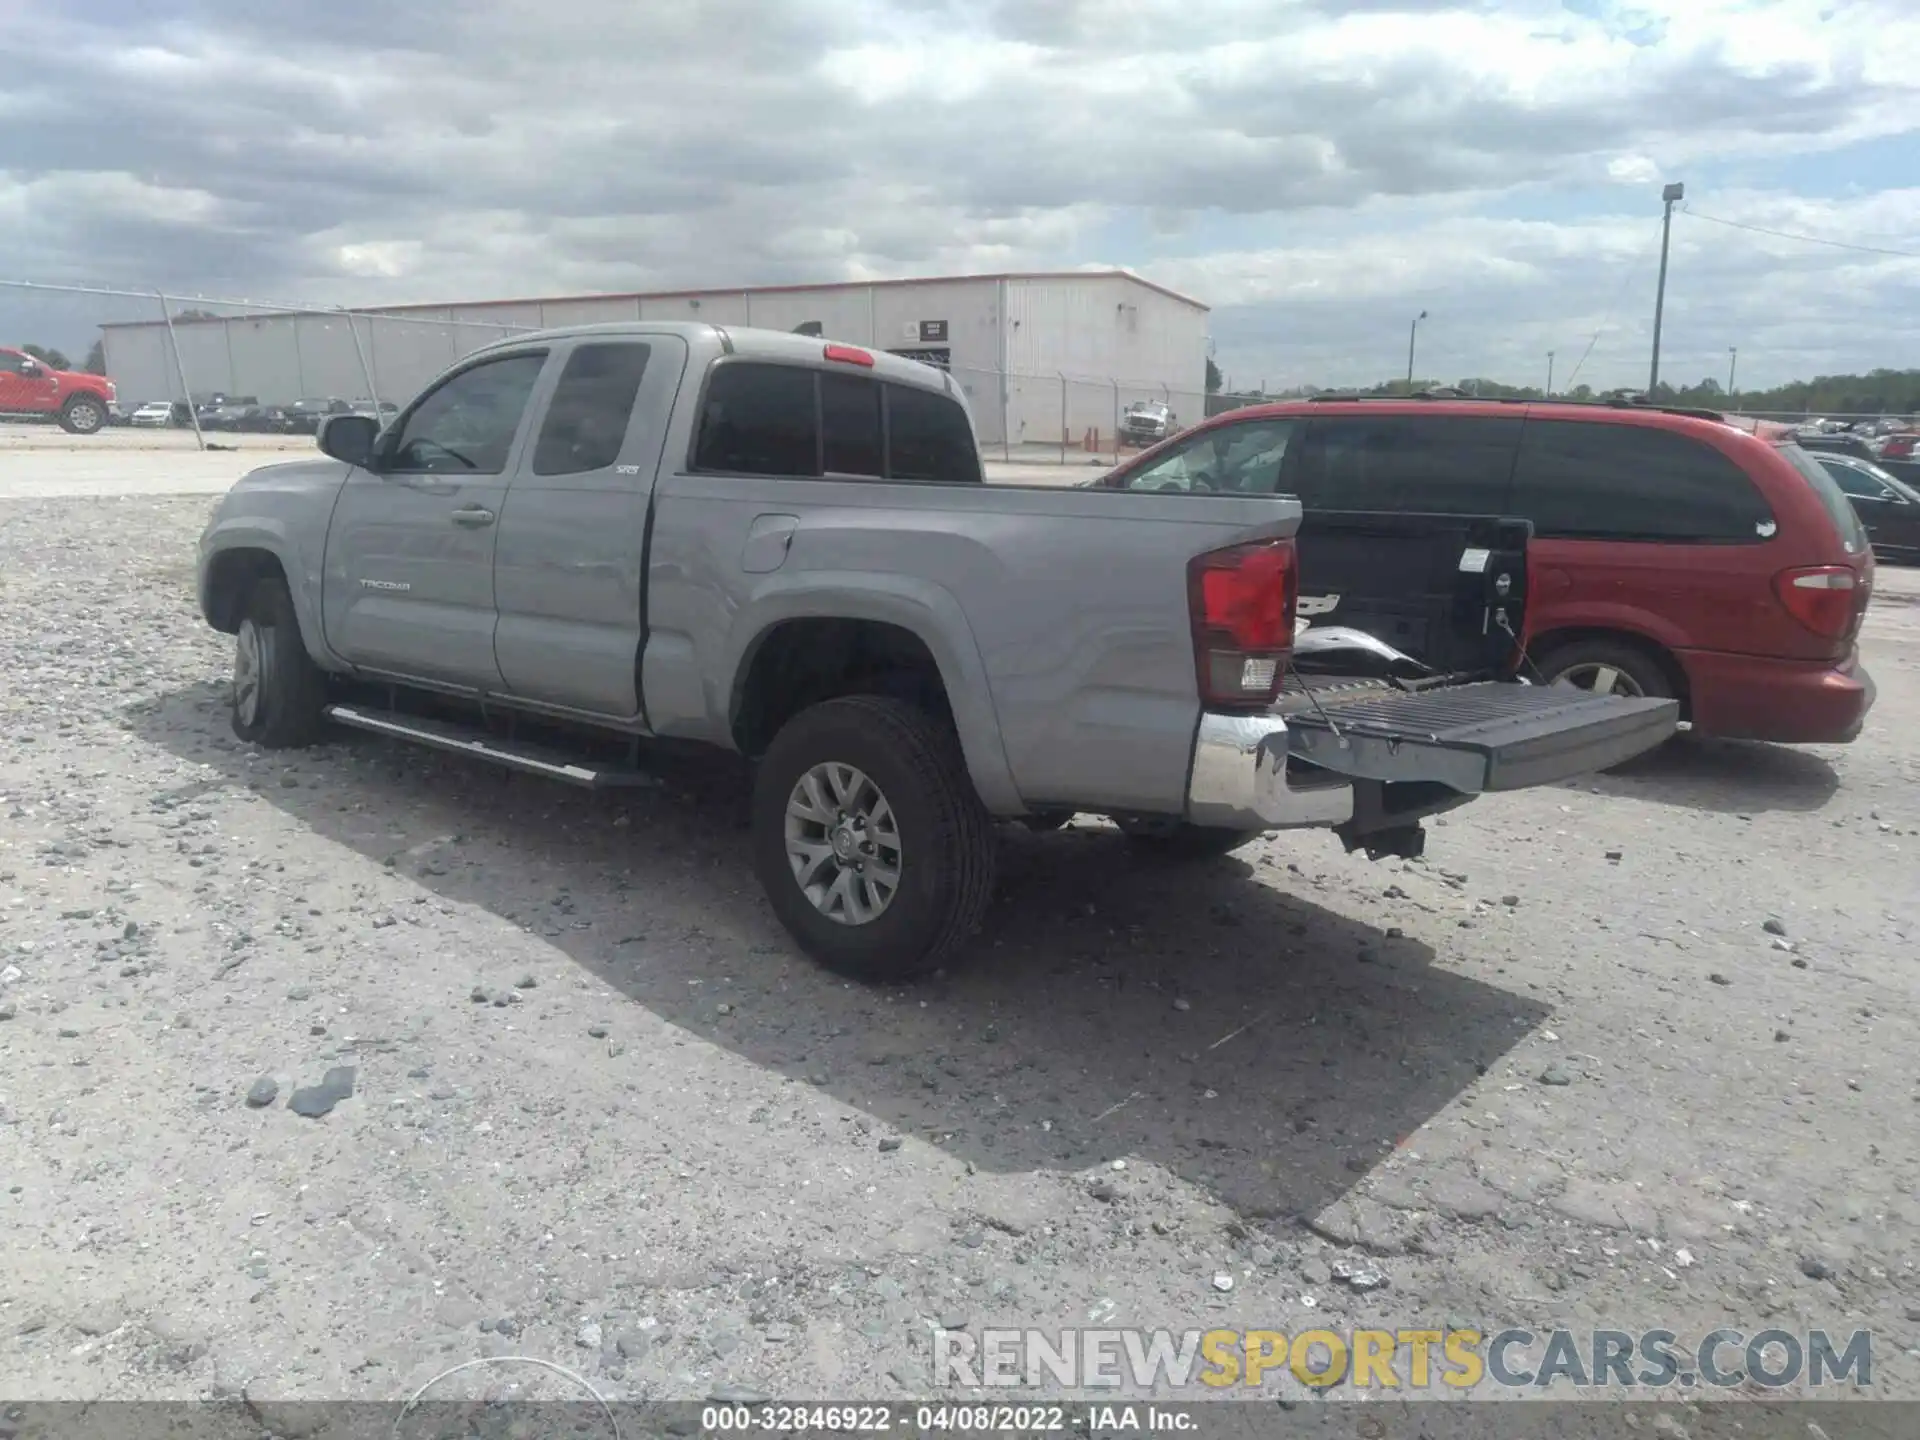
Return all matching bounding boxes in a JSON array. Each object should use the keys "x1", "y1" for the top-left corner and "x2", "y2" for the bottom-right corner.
[{"x1": 1187, "y1": 710, "x2": 1354, "y2": 829}]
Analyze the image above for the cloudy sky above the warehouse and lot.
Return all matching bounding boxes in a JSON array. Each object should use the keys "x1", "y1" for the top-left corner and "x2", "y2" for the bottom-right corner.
[{"x1": 0, "y1": 0, "x2": 1920, "y2": 388}]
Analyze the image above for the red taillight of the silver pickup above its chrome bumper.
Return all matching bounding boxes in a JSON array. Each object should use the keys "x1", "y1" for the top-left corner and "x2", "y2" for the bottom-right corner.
[{"x1": 1187, "y1": 540, "x2": 1300, "y2": 708}]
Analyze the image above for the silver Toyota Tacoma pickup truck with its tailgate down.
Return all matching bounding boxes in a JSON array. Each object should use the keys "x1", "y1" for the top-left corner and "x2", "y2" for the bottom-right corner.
[{"x1": 187, "y1": 323, "x2": 1676, "y2": 979}]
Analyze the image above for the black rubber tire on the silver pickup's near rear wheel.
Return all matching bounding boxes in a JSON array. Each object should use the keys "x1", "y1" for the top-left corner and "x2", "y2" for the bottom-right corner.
[{"x1": 753, "y1": 695, "x2": 995, "y2": 981}]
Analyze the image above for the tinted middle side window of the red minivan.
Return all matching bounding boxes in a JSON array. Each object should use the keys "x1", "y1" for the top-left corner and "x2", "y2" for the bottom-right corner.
[{"x1": 1298, "y1": 415, "x2": 1521, "y2": 515}]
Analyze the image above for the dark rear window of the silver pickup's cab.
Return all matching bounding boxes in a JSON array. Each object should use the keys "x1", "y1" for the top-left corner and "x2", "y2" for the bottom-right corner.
[{"x1": 693, "y1": 359, "x2": 985, "y2": 484}]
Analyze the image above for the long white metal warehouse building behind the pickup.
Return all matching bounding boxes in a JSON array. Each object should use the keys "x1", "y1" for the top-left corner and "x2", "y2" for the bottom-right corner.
[{"x1": 102, "y1": 271, "x2": 1208, "y2": 445}]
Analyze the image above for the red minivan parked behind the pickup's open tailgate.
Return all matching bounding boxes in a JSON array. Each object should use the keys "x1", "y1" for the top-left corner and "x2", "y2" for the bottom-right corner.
[{"x1": 1098, "y1": 397, "x2": 1874, "y2": 743}]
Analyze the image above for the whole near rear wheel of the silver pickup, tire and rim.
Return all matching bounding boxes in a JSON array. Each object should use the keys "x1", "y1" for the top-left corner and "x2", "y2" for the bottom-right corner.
[{"x1": 753, "y1": 695, "x2": 995, "y2": 981}]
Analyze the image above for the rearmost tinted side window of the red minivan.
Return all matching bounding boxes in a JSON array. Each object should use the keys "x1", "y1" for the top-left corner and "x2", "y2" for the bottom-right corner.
[{"x1": 1513, "y1": 420, "x2": 1774, "y2": 545}]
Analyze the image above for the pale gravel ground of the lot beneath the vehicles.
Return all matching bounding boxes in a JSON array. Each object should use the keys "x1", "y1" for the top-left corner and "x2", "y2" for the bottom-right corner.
[{"x1": 0, "y1": 485, "x2": 1920, "y2": 1434}]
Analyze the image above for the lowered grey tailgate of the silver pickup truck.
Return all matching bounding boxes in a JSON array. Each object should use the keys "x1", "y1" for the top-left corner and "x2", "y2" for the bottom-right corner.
[{"x1": 1279, "y1": 676, "x2": 1680, "y2": 795}]
